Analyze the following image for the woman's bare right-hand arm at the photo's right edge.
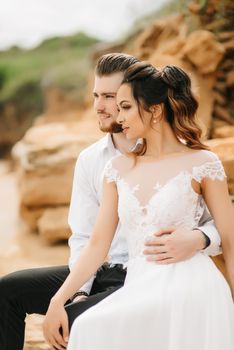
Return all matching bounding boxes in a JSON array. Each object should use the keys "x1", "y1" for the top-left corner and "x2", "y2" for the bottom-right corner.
[{"x1": 201, "y1": 178, "x2": 234, "y2": 297}]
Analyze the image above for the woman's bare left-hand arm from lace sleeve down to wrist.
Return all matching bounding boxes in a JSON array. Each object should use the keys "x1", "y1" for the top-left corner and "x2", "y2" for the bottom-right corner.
[{"x1": 53, "y1": 179, "x2": 118, "y2": 303}]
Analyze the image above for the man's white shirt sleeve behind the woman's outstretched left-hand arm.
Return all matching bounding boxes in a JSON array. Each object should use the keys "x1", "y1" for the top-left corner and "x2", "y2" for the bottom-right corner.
[{"x1": 68, "y1": 153, "x2": 99, "y2": 294}]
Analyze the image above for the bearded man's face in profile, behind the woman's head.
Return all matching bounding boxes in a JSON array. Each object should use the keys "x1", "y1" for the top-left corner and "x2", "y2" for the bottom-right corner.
[{"x1": 93, "y1": 72, "x2": 123, "y2": 133}]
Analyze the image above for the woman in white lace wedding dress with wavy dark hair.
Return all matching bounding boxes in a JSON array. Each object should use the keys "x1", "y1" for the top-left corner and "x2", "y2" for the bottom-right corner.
[{"x1": 44, "y1": 62, "x2": 234, "y2": 350}]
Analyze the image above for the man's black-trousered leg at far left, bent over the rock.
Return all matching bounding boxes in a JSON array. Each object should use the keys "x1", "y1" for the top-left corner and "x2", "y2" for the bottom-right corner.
[{"x1": 0, "y1": 266, "x2": 69, "y2": 350}]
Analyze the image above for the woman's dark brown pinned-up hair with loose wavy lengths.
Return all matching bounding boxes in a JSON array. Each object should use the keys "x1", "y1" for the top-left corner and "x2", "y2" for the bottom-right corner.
[{"x1": 122, "y1": 62, "x2": 208, "y2": 155}]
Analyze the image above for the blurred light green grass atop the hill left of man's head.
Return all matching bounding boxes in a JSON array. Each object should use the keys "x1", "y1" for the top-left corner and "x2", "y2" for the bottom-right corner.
[{"x1": 0, "y1": 33, "x2": 98, "y2": 103}]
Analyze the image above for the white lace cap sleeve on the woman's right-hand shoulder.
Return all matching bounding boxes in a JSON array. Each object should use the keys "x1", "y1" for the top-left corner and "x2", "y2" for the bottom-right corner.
[{"x1": 193, "y1": 152, "x2": 226, "y2": 183}]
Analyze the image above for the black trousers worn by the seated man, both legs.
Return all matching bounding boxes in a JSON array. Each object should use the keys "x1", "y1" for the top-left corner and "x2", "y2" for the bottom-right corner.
[{"x1": 0, "y1": 264, "x2": 126, "y2": 350}]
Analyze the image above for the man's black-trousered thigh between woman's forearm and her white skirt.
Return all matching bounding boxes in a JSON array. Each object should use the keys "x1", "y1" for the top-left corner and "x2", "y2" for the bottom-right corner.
[{"x1": 65, "y1": 264, "x2": 126, "y2": 329}]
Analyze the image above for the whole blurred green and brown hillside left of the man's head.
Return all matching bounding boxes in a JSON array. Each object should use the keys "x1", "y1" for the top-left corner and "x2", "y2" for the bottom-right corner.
[{"x1": 0, "y1": 33, "x2": 98, "y2": 156}]
